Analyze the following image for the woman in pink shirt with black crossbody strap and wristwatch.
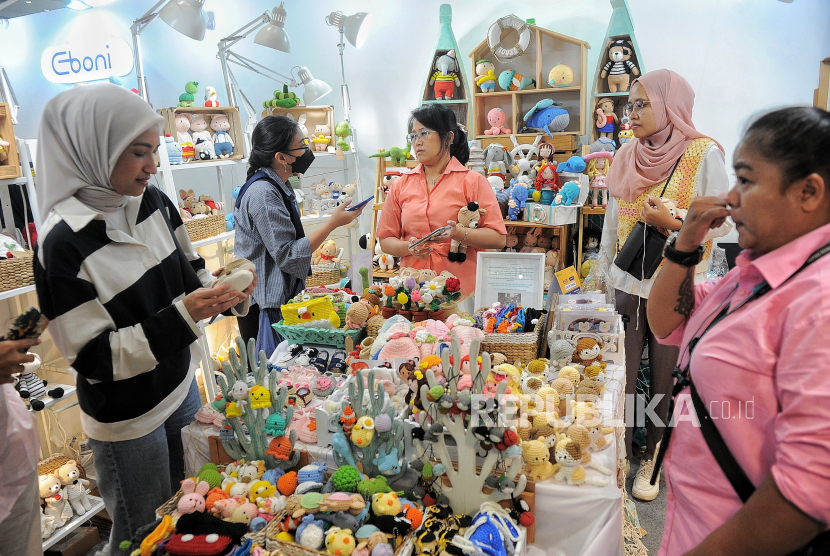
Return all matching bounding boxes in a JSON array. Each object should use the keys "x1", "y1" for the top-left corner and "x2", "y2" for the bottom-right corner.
[{"x1": 648, "y1": 107, "x2": 830, "y2": 556}]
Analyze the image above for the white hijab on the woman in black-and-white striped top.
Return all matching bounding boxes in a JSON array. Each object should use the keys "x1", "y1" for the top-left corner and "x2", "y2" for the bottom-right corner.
[{"x1": 35, "y1": 83, "x2": 164, "y2": 226}]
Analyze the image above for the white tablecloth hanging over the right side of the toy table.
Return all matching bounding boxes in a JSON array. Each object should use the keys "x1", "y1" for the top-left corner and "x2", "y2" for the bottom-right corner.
[{"x1": 533, "y1": 365, "x2": 625, "y2": 556}]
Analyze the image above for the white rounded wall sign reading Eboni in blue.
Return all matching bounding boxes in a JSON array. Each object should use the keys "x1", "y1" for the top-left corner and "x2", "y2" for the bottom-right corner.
[{"x1": 40, "y1": 36, "x2": 133, "y2": 83}]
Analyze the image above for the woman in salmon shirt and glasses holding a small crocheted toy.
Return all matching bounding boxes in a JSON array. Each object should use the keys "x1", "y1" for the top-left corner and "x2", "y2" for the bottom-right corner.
[{"x1": 377, "y1": 104, "x2": 507, "y2": 295}]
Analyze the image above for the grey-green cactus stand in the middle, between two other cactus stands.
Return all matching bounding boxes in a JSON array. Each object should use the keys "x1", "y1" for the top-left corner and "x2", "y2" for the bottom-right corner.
[{"x1": 334, "y1": 371, "x2": 408, "y2": 483}]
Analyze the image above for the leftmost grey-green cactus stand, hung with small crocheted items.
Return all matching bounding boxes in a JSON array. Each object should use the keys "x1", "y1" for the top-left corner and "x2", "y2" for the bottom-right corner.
[{"x1": 217, "y1": 337, "x2": 300, "y2": 470}]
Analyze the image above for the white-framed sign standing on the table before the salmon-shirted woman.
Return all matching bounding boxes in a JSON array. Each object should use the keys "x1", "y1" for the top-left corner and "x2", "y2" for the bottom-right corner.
[{"x1": 476, "y1": 251, "x2": 545, "y2": 309}]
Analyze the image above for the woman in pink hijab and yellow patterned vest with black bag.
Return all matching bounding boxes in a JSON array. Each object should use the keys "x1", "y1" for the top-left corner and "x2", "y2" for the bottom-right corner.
[{"x1": 601, "y1": 69, "x2": 729, "y2": 500}]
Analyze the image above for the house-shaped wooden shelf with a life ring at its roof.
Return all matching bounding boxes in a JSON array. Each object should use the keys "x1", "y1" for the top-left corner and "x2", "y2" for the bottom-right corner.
[{"x1": 470, "y1": 25, "x2": 590, "y2": 161}]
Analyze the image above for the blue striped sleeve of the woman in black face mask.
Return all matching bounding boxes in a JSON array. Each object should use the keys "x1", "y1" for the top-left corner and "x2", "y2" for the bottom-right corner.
[{"x1": 243, "y1": 181, "x2": 311, "y2": 280}]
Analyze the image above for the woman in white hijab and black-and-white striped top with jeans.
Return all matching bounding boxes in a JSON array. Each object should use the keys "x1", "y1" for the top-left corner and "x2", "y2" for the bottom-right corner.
[{"x1": 35, "y1": 84, "x2": 254, "y2": 553}]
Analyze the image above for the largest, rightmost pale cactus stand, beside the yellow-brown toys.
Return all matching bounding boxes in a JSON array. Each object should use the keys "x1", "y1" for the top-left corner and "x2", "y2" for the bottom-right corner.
[{"x1": 413, "y1": 336, "x2": 527, "y2": 515}]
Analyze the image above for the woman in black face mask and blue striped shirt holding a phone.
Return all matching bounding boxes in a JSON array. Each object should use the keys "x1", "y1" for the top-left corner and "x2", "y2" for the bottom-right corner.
[{"x1": 234, "y1": 116, "x2": 363, "y2": 356}]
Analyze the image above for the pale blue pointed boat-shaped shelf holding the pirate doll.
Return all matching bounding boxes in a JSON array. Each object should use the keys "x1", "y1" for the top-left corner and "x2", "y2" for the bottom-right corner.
[{"x1": 589, "y1": 0, "x2": 646, "y2": 145}]
